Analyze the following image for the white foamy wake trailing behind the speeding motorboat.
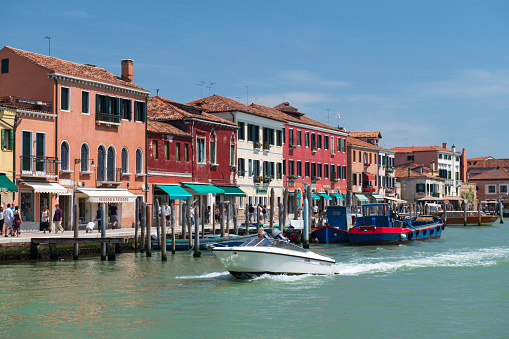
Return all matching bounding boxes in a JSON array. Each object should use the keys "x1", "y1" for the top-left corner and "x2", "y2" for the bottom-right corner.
[{"x1": 336, "y1": 248, "x2": 509, "y2": 275}]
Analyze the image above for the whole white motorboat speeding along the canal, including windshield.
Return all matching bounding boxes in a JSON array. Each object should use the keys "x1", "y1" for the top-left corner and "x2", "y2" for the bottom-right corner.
[{"x1": 209, "y1": 230, "x2": 336, "y2": 279}]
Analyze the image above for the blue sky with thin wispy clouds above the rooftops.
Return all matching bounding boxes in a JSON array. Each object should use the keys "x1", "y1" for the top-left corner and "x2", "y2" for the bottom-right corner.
[{"x1": 0, "y1": 0, "x2": 509, "y2": 158}]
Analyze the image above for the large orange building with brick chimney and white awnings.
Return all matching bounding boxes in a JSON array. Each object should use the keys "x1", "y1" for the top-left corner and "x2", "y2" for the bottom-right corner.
[{"x1": 0, "y1": 47, "x2": 150, "y2": 229}]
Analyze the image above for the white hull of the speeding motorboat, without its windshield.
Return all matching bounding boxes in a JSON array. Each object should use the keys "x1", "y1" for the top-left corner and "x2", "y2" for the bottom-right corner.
[{"x1": 212, "y1": 247, "x2": 335, "y2": 278}]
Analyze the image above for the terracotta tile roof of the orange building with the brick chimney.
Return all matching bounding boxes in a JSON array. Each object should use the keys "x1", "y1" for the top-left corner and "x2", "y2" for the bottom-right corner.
[{"x1": 5, "y1": 46, "x2": 149, "y2": 92}]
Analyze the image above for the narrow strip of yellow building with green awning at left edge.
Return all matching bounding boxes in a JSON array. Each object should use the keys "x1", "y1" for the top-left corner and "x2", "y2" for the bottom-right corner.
[{"x1": 0, "y1": 106, "x2": 18, "y2": 208}]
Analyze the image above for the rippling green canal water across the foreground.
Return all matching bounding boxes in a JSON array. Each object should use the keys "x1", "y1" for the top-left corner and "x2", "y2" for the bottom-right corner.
[{"x1": 0, "y1": 221, "x2": 509, "y2": 338}]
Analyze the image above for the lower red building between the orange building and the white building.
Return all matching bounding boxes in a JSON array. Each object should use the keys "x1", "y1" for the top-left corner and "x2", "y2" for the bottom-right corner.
[{"x1": 147, "y1": 96, "x2": 237, "y2": 222}]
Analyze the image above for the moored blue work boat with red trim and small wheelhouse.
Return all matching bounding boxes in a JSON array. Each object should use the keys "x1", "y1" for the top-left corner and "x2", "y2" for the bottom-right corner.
[{"x1": 348, "y1": 204, "x2": 444, "y2": 245}]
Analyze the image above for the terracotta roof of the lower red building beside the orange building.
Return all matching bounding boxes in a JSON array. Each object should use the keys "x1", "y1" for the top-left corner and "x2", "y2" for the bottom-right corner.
[{"x1": 147, "y1": 96, "x2": 237, "y2": 127}]
